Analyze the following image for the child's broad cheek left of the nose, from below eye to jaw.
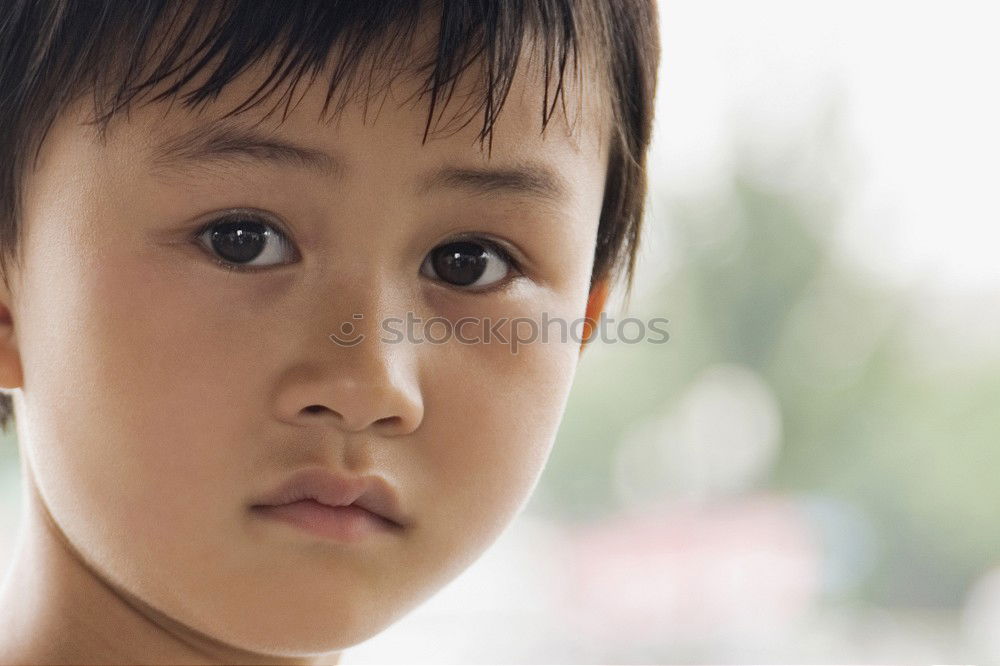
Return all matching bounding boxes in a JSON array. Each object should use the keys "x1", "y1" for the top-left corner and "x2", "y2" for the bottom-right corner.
[{"x1": 14, "y1": 232, "x2": 286, "y2": 608}]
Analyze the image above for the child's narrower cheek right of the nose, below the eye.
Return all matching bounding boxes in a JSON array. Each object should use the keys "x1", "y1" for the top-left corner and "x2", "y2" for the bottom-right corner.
[{"x1": 416, "y1": 296, "x2": 578, "y2": 550}]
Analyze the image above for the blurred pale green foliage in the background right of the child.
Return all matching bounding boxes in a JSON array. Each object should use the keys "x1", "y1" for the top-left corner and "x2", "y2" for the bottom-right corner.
[{"x1": 541, "y1": 94, "x2": 1000, "y2": 607}]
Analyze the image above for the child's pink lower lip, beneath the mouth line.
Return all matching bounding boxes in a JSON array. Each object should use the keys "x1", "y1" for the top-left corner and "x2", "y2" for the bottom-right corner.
[{"x1": 253, "y1": 500, "x2": 399, "y2": 542}]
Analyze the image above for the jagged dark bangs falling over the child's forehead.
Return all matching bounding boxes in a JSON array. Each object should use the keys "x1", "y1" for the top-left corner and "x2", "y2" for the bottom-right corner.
[{"x1": 41, "y1": 0, "x2": 584, "y2": 154}]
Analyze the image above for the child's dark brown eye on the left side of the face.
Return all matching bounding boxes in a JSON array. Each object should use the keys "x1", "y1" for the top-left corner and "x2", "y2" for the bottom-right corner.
[{"x1": 198, "y1": 214, "x2": 295, "y2": 269}]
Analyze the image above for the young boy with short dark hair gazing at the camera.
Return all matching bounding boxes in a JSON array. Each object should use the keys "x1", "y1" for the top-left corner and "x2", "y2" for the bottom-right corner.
[{"x1": 0, "y1": 0, "x2": 659, "y2": 664}]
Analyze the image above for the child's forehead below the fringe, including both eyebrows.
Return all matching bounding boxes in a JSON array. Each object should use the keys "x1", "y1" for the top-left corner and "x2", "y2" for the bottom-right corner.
[{"x1": 76, "y1": 23, "x2": 608, "y2": 220}]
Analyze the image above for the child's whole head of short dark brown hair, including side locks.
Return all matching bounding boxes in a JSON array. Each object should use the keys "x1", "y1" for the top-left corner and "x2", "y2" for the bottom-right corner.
[{"x1": 0, "y1": 0, "x2": 660, "y2": 429}]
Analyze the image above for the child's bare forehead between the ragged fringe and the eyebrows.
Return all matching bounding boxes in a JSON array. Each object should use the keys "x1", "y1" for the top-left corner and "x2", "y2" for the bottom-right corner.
[{"x1": 88, "y1": 10, "x2": 610, "y2": 193}]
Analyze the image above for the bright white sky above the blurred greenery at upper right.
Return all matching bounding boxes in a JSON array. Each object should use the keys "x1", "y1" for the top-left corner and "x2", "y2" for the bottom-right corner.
[{"x1": 647, "y1": 0, "x2": 1000, "y2": 291}]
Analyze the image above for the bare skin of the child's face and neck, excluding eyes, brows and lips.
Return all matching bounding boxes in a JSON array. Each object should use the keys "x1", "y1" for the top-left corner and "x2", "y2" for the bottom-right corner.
[{"x1": 0, "y1": 20, "x2": 607, "y2": 664}]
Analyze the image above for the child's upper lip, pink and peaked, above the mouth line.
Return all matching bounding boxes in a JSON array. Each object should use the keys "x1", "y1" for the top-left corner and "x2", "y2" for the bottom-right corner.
[{"x1": 253, "y1": 468, "x2": 409, "y2": 527}]
